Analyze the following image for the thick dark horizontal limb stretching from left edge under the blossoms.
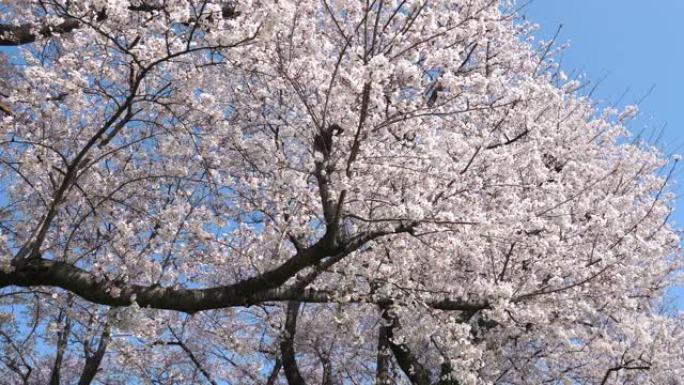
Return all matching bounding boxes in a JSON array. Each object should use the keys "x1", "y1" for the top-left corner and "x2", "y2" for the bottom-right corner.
[{"x1": 0, "y1": 255, "x2": 490, "y2": 313}]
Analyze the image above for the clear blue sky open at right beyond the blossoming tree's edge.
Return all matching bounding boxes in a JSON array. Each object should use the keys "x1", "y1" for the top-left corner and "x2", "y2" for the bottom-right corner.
[{"x1": 520, "y1": 0, "x2": 684, "y2": 310}]
